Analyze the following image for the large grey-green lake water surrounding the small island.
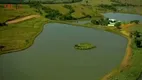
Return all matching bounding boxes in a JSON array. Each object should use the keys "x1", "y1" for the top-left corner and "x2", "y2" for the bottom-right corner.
[{"x1": 0, "y1": 23, "x2": 127, "y2": 80}]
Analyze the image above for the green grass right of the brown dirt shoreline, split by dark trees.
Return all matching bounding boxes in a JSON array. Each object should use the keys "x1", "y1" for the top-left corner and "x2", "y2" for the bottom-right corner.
[{"x1": 107, "y1": 24, "x2": 142, "y2": 80}]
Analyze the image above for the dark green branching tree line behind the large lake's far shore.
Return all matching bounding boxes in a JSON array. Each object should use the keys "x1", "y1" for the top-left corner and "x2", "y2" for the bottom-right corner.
[{"x1": 29, "y1": 1, "x2": 92, "y2": 20}]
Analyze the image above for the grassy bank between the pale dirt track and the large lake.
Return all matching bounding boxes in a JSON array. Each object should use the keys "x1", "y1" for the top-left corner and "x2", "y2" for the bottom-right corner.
[{"x1": 0, "y1": 17, "x2": 47, "y2": 54}]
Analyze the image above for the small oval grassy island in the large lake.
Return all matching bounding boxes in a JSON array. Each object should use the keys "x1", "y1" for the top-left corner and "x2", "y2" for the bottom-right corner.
[{"x1": 74, "y1": 43, "x2": 96, "y2": 50}]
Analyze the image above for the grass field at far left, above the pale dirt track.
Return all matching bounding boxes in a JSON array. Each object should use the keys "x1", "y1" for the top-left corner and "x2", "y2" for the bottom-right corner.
[{"x1": 0, "y1": 4, "x2": 37, "y2": 22}]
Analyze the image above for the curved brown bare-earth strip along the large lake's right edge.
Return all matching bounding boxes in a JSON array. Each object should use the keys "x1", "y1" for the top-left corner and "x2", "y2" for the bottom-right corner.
[{"x1": 101, "y1": 33, "x2": 132, "y2": 80}]
